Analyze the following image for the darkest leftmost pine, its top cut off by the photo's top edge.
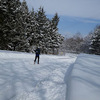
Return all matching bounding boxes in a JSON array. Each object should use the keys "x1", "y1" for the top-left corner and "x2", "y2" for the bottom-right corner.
[{"x1": 0, "y1": 0, "x2": 16, "y2": 49}]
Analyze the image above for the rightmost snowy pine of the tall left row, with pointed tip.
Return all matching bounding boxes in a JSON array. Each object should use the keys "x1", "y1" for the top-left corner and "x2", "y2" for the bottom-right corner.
[{"x1": 50, "y1": 13, "x2": 64, "y2": 54}]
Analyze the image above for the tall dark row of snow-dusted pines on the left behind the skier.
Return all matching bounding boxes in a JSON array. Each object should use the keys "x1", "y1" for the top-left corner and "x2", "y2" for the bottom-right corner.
[{"x1": 0, "y1": 0, "x2": 64, "y2": 54}]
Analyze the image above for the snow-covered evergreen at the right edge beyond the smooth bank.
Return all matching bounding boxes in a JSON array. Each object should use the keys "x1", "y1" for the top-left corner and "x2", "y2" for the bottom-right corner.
[{"x1": 90, "y1": 26, "x2": 100, "y2": 55}]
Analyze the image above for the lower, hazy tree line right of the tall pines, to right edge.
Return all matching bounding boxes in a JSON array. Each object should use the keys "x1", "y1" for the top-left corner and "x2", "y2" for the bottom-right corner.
[{"x1": 60, "y1": 25, "x2": 100, "y2": 55}]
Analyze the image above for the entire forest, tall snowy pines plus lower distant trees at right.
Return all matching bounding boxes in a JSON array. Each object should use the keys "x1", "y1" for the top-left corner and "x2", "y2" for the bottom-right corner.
[{"x1": 0, "y1": 0, "x2": 100, "y2": 55}]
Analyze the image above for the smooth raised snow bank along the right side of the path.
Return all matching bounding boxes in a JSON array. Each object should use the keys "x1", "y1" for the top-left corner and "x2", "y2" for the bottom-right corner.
[{"x1": 65, "y1": 54, "x2": 100, "y2": 100}]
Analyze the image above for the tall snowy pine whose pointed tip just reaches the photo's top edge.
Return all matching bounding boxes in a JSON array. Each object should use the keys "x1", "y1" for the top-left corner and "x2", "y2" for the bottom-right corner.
[{"x1": 12, "y1": 0, "x2": 30, "y2": 52}]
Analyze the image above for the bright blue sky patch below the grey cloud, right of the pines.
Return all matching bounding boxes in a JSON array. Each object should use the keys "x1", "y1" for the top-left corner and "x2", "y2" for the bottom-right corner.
[{"x1": 58, "y1": 16, "x2": 100, "y2": 36}]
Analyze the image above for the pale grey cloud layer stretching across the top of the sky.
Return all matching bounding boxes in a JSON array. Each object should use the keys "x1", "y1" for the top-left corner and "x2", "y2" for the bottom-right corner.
[{"x1": 21, "y1": 0, "x2": 100, "y2": 19}]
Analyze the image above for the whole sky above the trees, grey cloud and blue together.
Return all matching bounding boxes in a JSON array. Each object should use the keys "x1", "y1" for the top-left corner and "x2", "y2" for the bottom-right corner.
[{"x1": 21, "y1": 0, "x2": 100, "y2": 36}]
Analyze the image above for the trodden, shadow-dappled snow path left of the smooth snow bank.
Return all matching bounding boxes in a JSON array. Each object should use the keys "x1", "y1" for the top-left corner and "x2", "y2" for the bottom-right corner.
[{"x1": 0, "y1": 51, "x2": 76, "y2": 100}]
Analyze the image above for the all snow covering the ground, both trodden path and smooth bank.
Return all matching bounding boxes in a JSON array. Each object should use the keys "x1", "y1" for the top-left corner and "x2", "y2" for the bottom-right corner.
[{"x1": 0, "y1": 50, "x2": 100, "y2": 100}]
